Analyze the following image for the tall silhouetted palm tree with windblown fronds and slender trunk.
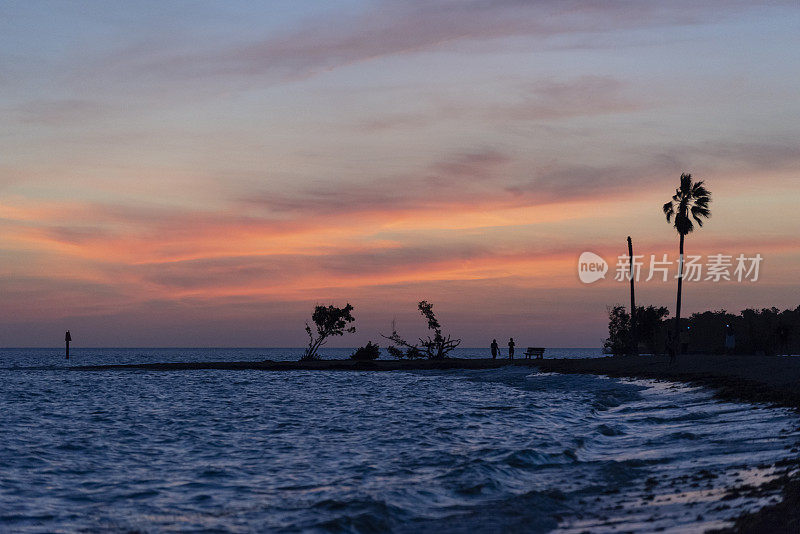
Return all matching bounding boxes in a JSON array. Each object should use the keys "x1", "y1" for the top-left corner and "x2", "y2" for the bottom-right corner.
[{"x1": 663, "y1": 173, "x2": 711, "y2": 362}]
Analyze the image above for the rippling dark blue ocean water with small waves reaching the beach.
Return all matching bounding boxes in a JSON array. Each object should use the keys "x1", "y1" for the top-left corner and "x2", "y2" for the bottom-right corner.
[{"x1": 0, "y1": 349, "x2": 800, "y2": 533}]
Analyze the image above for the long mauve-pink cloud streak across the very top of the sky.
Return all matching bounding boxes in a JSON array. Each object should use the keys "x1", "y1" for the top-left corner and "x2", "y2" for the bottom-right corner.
[{"x1": 101, "y1": 0, "x2": 788, "y2": 81}]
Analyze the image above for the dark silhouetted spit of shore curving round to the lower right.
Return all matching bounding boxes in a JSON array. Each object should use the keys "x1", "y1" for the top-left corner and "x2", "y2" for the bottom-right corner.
[{"x1": 67, "y1": 354, "x2": 800, "y2": 534}]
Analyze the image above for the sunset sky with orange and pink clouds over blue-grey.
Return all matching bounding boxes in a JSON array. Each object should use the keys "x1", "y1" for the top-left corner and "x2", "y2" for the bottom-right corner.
[{"x1": 0, "y1": 0, "x2": 800, "y2": 347}]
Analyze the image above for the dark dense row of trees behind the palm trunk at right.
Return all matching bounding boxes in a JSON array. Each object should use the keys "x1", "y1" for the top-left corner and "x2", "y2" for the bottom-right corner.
[{"x1": 603, "y1": 305, "x2": 800, "y2": 355}]
